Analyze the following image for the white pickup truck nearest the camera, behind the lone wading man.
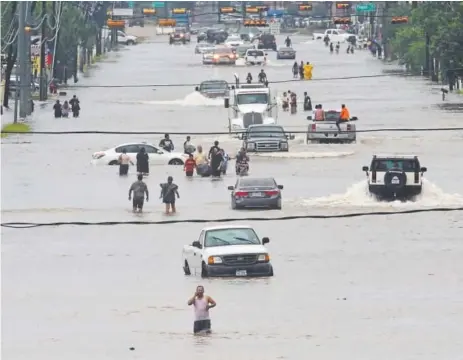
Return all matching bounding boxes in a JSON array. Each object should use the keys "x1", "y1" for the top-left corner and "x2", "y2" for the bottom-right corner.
[{"x1": 182, "y1": 225, "x2": 273, "y2": 278}]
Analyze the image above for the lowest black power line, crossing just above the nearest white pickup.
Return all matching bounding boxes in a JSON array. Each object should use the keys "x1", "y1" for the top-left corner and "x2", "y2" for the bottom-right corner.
[{"x1": 1, "y1": 207, "x2": 463, "y2": 229}]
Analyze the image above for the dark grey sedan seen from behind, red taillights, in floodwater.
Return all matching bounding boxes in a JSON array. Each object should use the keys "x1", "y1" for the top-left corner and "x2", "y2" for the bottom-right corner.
[{"x1": 228, "y1": 177, "x2": 283, "y2": 210}]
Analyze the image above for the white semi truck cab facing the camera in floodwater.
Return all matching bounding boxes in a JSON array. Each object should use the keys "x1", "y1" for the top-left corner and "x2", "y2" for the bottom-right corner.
[{"x1": 224, "y1": 84, "x2": 278, "y2": 136}]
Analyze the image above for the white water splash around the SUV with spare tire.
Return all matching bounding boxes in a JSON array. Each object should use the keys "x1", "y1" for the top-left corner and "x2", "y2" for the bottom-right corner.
[{"x1": 303, "y1": 179, "x2": 463, "y2": 209}]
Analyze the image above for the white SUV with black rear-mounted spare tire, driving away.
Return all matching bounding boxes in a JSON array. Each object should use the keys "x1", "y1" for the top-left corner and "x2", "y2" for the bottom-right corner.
[{"x1": 362, "y1": 155, "x2": 427, "y2": 201}]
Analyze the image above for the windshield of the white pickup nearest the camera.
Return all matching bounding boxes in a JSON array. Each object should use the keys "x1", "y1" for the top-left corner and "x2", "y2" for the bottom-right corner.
[{"x1": 204, "y1": 228, "x2": 260, "y2": 247}]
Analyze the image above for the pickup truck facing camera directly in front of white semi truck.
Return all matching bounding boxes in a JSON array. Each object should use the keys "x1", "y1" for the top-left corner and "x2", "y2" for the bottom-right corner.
[{"x1": 240, "y1": 124, "x2": 294, "y2": 152}]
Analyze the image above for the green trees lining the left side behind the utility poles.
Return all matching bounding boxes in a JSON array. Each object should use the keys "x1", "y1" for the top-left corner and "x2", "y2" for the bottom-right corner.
[{"x1": 1, "y1": 1, "x2": 112, "y2": 107}]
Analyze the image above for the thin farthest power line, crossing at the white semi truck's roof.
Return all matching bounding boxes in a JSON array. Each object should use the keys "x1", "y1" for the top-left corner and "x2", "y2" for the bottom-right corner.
[{"x1": 64, "y1": 73, "x2": 416, "y2": 89}]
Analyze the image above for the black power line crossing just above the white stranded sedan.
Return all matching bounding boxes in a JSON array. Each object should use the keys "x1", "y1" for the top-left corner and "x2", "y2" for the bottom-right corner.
[{"x1": 2, "y1": 128, "x2": 463, "y2": 135}]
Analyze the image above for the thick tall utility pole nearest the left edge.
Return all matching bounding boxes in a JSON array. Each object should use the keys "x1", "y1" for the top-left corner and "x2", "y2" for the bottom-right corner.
[{"x1": 18, "y1": 1, "x2": 30, "y2": 119}]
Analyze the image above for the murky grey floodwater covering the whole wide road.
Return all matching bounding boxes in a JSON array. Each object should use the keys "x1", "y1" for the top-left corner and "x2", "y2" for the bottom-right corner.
[{"x1": 2, "y1": 31, "x2": 463, "y2": 360}]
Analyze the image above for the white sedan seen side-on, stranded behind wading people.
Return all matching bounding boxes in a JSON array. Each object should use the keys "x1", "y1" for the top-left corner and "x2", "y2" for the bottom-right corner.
[{"x1": 92, "y1": 142, "x2": 188, "y2": 165}]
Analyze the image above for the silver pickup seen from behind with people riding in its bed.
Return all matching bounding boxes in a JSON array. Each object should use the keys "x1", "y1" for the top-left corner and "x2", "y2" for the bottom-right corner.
[{"x1": 306, "y1": 110, "x2": 358, "y2": 144}]
